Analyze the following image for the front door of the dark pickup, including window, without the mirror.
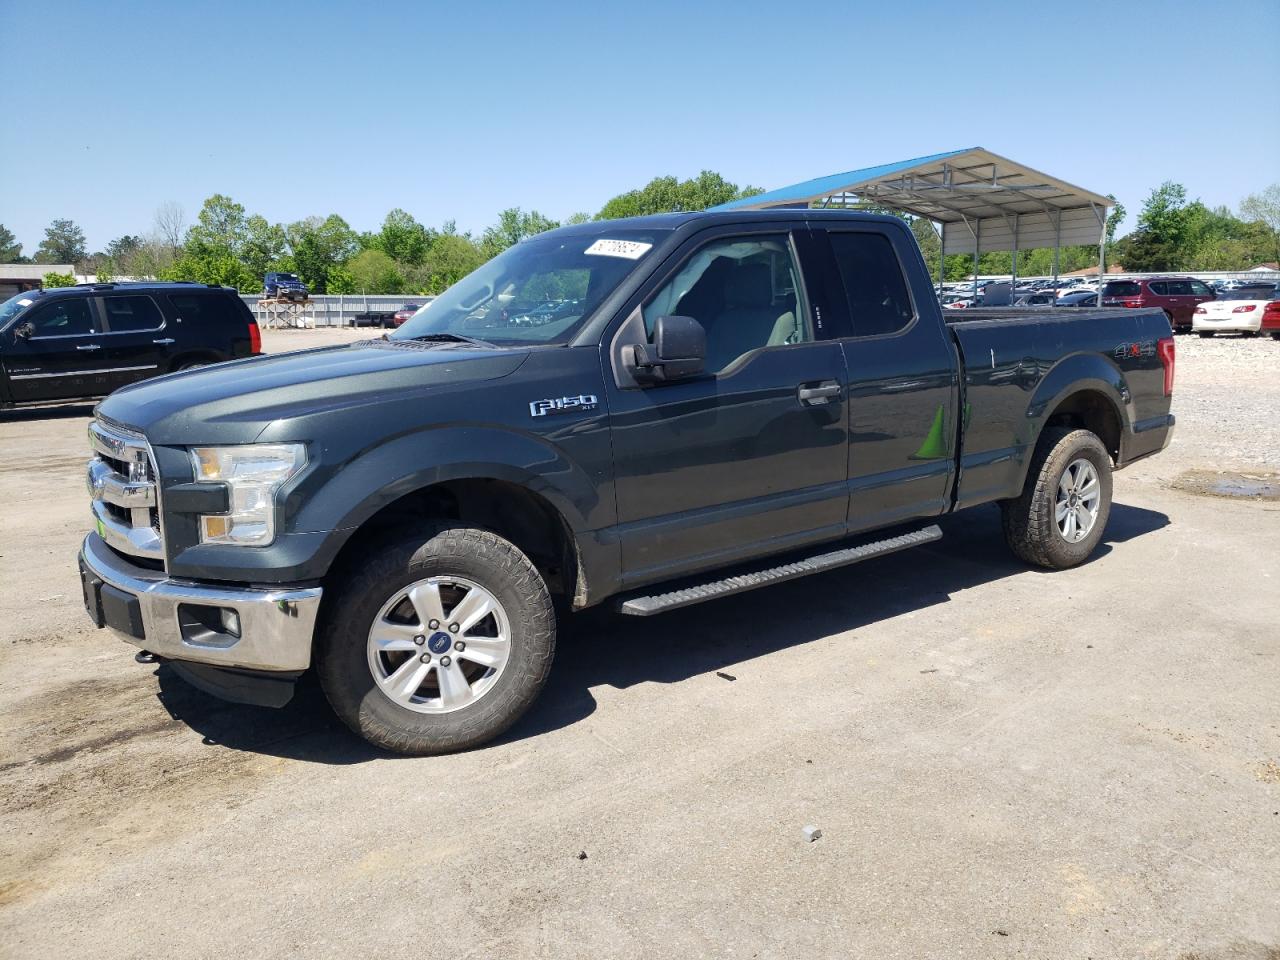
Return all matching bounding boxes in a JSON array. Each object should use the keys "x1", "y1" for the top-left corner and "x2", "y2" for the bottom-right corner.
[{"x1": 605, "y1": 223, "x2": 849, "y2": 586}]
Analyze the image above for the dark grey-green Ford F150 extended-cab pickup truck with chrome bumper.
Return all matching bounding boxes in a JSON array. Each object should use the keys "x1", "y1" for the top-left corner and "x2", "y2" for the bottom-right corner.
[{"x1": 79, "y1": 210, "x2": 1174, "y2": 753}]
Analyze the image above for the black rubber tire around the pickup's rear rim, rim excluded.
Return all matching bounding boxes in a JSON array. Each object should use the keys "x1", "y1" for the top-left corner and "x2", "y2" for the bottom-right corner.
[{"x1": 1000, "y1": 428, "x2": 1111, "y2": 570}]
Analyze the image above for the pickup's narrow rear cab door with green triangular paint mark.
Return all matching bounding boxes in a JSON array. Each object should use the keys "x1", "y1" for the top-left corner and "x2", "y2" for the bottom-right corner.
[{"x1": 824, "y1": 224, "x2": 959, "y2": 532}]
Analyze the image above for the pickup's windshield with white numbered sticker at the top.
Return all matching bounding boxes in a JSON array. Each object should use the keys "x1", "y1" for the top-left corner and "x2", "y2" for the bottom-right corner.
[{"x1": 390, "y1": 224, "x2": 668, "y2": 344}]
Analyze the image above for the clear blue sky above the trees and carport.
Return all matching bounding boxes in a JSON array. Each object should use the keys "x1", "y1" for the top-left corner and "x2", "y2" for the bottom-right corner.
[{"x1": 0, "y1": 0, "x2": 1280, "y2": 253}]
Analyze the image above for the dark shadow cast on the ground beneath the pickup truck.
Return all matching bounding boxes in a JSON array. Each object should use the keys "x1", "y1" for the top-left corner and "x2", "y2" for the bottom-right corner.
[{"x1": 149, "y1": 503, "x2": 1169, "y2": 764}]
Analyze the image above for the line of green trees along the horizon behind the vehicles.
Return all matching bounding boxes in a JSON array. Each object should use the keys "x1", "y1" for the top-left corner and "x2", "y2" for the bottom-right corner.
[{"x1": 0, "y1": 170, "x2": 1280, "y2": 294}]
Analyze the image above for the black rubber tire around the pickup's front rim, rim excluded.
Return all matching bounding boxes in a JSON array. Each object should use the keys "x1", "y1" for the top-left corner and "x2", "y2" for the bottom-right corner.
[{"x1": 316, "y1": 525, "x2": 556, "y2": 755}]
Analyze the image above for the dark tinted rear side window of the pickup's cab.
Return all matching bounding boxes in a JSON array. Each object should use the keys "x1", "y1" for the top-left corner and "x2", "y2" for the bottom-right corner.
[{"x1": 828, "y1": 233, "x2": 915, "y2": 337}]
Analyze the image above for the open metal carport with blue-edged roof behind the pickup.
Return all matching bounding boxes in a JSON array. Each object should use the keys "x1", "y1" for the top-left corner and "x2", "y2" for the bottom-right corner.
[{"x1": 714, "y1": 147, "x2": 1115, "y2": 294}]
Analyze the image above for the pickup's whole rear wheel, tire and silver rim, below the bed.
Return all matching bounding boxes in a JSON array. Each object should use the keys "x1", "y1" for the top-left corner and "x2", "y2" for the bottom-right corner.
[{"x1": 1000, "y1": 428, "x2": 1111, "y2": 570}]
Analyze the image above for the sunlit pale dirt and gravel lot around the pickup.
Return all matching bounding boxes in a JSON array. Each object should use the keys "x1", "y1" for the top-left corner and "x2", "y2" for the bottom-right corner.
[{"x1": 0, "y1": 332, "x2": 1280, "y2": 960}]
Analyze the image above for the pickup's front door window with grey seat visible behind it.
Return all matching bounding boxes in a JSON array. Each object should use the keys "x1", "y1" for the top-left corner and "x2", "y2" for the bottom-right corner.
[{"x1": 644, "y1": 233, "x2": 813, "y2": 374}]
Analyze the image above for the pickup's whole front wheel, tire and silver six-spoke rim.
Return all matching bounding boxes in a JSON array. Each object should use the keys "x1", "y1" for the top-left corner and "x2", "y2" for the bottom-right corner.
[{"x1": 316, "y1": 526, "x2": 556, "y2": 754}]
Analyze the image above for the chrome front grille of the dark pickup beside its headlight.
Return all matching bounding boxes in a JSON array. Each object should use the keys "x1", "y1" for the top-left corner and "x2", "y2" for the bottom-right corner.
[{"x1": 88, "y1": 420, "x2": 164, "y2": 561}]
